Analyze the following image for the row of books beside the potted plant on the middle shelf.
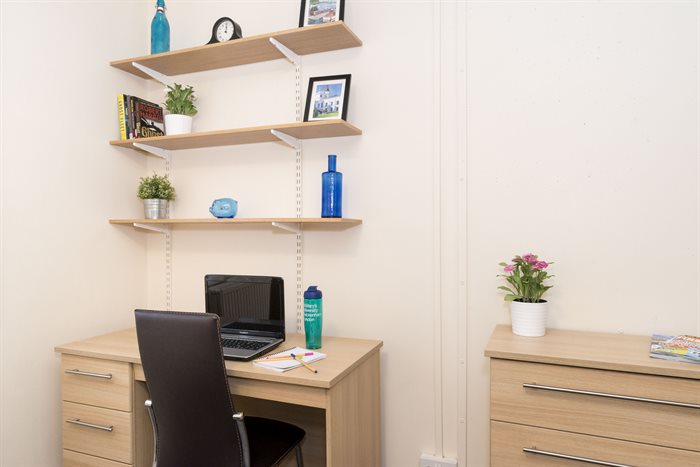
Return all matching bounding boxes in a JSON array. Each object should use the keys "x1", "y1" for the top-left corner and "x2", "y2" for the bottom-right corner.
[{"x1": 117, "y1": 94, "x2": 165, "y2": 140}]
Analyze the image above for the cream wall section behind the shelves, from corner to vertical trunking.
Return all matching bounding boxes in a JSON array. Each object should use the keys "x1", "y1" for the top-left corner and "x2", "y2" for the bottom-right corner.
[{"x1": 138, "y1": 1, "x2": 442, "y2": 465}]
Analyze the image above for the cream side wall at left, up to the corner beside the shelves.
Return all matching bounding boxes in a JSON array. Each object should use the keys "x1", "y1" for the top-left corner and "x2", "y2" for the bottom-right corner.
[{"x1": 0, "y1": 2, "x2": 148, "y2": 467}]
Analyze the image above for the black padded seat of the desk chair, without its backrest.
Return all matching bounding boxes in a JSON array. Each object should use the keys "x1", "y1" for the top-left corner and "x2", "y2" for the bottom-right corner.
[{"x1": 245, "y1": 417, "x2": 306, "y2": 467}]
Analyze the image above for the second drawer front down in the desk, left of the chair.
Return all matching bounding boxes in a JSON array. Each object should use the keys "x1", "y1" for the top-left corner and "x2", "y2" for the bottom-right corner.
[{"x1": 63, "y1": 402, "x2": 133, "y2": 464}]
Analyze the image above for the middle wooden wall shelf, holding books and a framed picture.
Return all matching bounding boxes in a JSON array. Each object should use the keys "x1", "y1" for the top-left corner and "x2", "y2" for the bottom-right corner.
[{"x1": 109, "y1": 120, "x2": 362, "y2": 150}]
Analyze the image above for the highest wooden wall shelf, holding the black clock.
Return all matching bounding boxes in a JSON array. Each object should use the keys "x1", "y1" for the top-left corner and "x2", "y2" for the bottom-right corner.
[{"x1": 110, "y1": 21, "x2": 362, "y2": 79}]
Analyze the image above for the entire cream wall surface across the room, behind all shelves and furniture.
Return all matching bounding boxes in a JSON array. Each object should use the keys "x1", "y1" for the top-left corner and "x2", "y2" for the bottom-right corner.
[{"x1": 0, "y1": 0, "x2": 700, "y2": 467}]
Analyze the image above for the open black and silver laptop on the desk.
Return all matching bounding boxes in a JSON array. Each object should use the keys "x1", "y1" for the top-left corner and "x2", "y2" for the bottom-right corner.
[{"x1": 204, "y1": 274, "x2": 285, "y2": 360}]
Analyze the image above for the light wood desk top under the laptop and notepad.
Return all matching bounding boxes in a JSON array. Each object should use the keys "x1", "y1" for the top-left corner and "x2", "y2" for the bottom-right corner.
[{"x1": 55, "y1": 328, "x2": 382, "y2": 388}]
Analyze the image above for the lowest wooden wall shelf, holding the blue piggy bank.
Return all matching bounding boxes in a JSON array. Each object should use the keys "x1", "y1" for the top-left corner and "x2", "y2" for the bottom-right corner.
[{"x1": 109, "y1": 217, "x2": 362, "y2": 231}]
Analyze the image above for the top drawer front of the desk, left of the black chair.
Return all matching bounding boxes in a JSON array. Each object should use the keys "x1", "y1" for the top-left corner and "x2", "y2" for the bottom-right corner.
[{"x1": 61, "y1": 355, "x2": 132, "y2": 412}]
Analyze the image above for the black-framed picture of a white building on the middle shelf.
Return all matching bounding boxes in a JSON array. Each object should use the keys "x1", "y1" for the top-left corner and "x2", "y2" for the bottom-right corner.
[{"x1": 304, "y1": 75, "x2": 350, "y2": 122}]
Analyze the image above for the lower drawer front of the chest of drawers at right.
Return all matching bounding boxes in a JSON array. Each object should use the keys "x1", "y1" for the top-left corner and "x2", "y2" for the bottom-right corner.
[{"x1": 491, "y1": 421, "x2": 700, "y2": 467}]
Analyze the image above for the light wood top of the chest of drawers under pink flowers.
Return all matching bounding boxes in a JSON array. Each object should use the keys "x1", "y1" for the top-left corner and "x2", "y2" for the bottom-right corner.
[{"x1": 484, "y1": 324, "x2": 700, "y2": 379}]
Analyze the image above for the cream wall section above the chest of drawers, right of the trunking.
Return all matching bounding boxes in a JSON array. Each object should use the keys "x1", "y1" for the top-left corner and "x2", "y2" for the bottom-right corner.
[{"x1": 467, "y1": 1, "x2": 700, "y2": 466}]
